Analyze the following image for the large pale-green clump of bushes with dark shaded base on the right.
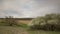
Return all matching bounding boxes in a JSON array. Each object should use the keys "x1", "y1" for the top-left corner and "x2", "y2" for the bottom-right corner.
[{"x1": 30, "y1": 14, "x2": 60, "y2": 31}]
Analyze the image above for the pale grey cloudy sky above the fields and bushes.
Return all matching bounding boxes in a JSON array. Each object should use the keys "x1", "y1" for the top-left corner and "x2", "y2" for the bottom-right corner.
[{"x1": 0, "y1": 0, "x2": 60, "y2": 18}]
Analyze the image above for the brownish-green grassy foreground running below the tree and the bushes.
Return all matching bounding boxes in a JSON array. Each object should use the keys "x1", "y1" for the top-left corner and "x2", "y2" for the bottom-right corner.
[{"x1": 0, "y1": 26, "x2": 60, "y2": 34}]
